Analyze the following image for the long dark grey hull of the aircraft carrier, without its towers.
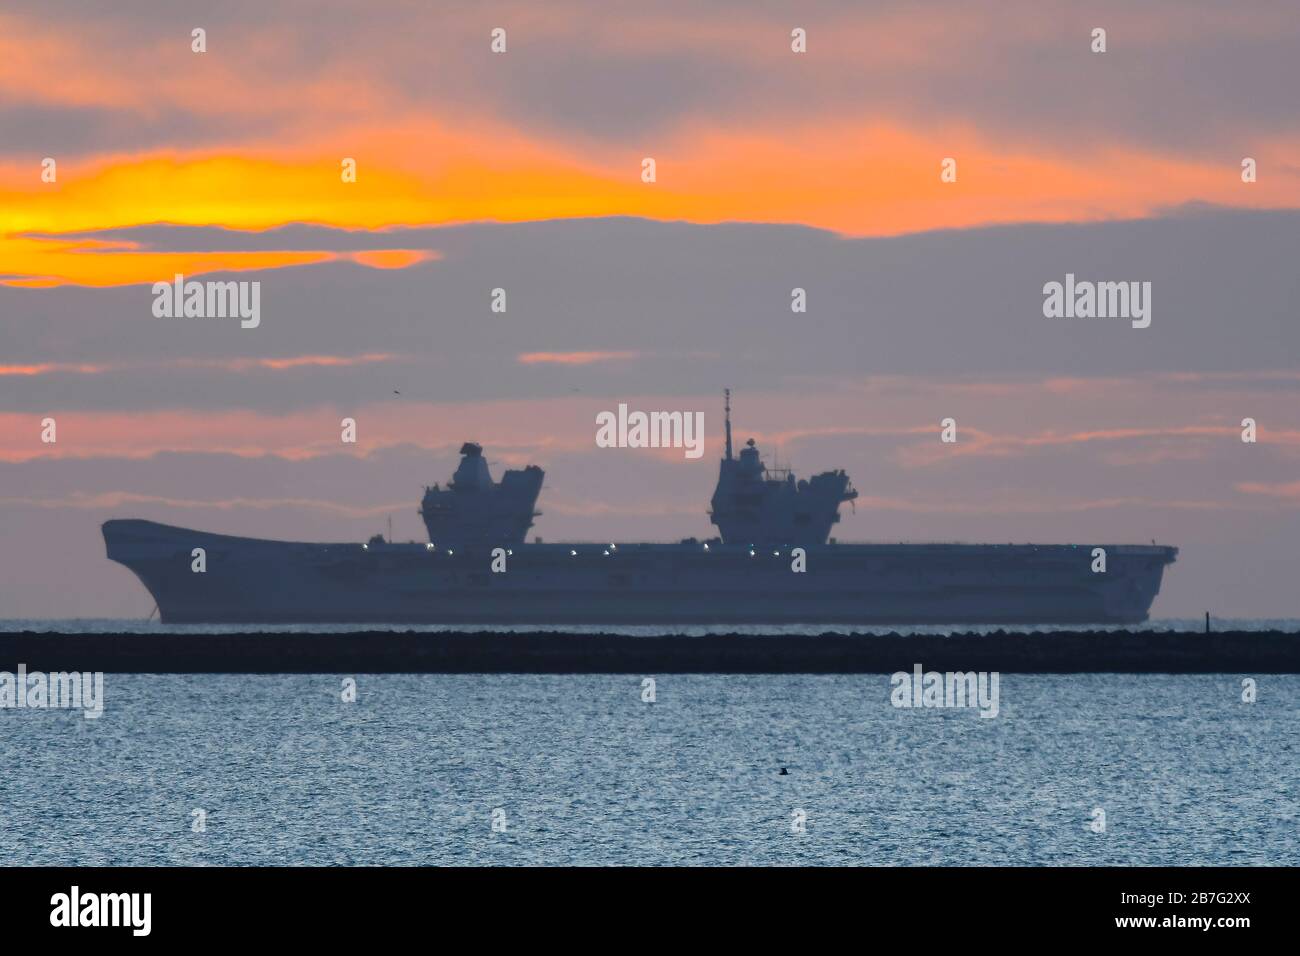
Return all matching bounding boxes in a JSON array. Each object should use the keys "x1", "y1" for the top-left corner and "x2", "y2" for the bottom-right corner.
[{"x1": 104, "y1": 520, "x2": 1177, "y2": 624}]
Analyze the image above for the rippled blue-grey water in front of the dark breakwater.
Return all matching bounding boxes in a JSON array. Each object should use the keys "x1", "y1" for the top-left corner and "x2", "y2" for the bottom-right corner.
[{"x1": 0, "y1": 674, "x2": 1300, "y2": 865}]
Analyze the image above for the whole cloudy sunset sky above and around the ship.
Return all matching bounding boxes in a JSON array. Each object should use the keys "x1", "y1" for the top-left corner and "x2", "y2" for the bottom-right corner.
[{"x1": 0, "y1": 0, "x2": 1300, "y2": 618}]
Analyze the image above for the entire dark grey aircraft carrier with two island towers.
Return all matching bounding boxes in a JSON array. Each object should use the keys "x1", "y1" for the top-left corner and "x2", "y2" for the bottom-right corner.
[{"x1": 103, "y1": 395, "x2": 1178, "y2": 626}]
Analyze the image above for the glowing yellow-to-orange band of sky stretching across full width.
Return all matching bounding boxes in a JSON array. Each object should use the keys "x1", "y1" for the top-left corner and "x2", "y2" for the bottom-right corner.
[{"x1": 0, "y1": 124, "x2": 1300, "y2": 286}]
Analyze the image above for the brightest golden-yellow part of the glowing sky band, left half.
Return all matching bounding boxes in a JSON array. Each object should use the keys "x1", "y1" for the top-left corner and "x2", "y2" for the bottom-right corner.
[{"x1": 0, "y1": 148, "x2": 639, "y2": 286}]
